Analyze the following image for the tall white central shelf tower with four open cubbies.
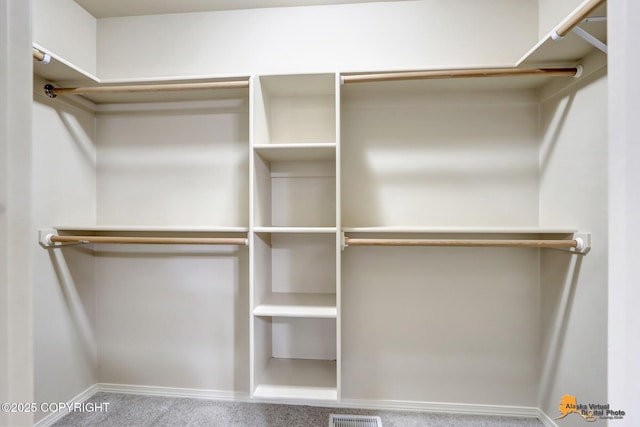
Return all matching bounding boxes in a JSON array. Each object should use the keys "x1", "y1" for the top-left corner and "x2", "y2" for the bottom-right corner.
[{"x1": 250, "y1": 74, "x2": 340, "y2": 400}]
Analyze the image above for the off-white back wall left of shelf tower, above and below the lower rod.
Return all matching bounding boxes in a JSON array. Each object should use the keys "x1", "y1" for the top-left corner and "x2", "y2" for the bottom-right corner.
[{"x1": 96, "y1": 103, "x2": 249, "y2": 396}]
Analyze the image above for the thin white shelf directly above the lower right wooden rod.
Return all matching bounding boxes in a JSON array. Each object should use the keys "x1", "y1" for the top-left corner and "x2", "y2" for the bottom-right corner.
[{"x1": 342, "y1": 226, "x2": 578, "y2": 234}]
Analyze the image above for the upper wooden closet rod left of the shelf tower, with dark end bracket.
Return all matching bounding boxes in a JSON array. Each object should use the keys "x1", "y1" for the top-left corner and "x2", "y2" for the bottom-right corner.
[{"x1": 44, "y1": 80, "x2": 249, "y2": 98}]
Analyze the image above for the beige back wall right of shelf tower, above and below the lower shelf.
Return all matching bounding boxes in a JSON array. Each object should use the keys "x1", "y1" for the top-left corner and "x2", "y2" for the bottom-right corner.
[{"x1": 341, "y1": 83, "x2": 540, "y2": 407}]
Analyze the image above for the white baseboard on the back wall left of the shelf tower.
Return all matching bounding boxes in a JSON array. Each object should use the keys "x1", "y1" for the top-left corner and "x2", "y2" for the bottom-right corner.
[{"x1": 97, "y1": 383, "x2": 249, "y2": 401}]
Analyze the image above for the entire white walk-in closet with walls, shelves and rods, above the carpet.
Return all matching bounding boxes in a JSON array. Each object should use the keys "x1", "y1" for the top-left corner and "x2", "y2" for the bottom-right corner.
[{"x1": 5, "y1": 0, "x2": 640, "y2": 426}]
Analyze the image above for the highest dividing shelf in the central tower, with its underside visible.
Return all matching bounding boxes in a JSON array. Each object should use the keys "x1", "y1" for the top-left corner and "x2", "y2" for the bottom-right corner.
[{"x1": 253, "y1": 142, "x2": 336, "y2": 162}]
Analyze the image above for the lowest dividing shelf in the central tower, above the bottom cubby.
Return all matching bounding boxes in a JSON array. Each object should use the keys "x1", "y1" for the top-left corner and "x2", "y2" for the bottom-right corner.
[{"x1": 253, "y1": 293, "x2": 338, "y2": 319}]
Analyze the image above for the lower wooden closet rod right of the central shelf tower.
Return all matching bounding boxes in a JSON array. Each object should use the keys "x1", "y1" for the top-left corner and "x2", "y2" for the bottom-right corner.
[{"x1": 344, "y1": 237, "x2": 583, "y2": 249}]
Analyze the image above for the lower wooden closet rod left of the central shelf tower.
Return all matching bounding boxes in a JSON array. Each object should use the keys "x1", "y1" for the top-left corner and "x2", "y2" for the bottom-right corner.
[{"x1": 46, "y1": 235, "x2": 247, "y2": 246}]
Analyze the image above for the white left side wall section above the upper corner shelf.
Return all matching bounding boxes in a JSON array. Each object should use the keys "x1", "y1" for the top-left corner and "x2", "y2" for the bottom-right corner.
[{"x1": 32, "y1": 0, "x2": 97, "y2": 75}]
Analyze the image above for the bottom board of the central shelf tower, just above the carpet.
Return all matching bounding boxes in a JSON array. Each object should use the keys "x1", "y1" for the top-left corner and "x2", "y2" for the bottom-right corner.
[{"x1": 253, "y1": 359, "x2": 338, "y2": 401}]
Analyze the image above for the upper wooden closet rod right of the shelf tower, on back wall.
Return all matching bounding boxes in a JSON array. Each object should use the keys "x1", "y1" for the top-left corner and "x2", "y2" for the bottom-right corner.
[{"x1": 342, "y1": 67, "x2": 579, "y2": 83}]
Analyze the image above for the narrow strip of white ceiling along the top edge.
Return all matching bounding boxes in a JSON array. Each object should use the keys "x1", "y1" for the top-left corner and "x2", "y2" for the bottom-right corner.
[{"x1": 74, "y1": 0, "x2": 412, "y2": 18}]
